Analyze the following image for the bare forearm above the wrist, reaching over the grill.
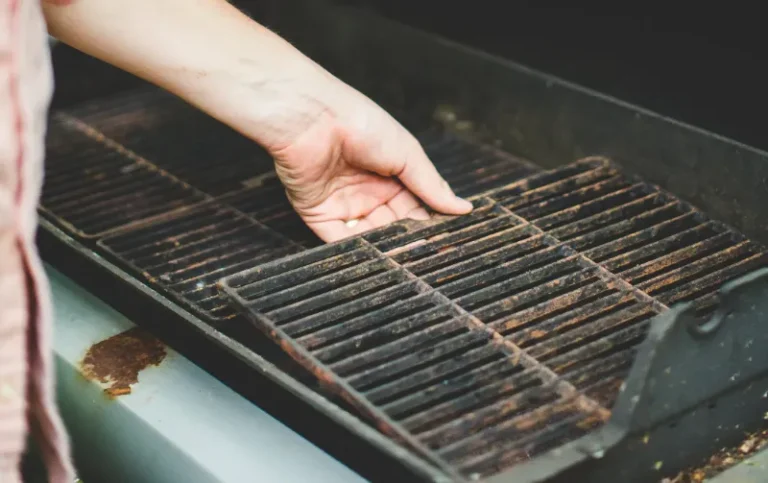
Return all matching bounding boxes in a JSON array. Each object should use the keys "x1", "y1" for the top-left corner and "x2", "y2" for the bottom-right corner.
[{"x1": 45, "y1": 0, "x2": 342, "y2": 149}]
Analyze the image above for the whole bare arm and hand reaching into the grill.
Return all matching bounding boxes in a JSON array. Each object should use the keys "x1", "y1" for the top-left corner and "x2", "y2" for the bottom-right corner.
[{"x1": 43, "y1": 0, "x2": 472, "y2": 242}]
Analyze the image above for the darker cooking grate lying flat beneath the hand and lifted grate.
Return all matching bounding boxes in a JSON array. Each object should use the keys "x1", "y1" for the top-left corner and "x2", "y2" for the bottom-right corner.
[{"x1": 40, "y1": 88, "x2": 537, "y2": 321}]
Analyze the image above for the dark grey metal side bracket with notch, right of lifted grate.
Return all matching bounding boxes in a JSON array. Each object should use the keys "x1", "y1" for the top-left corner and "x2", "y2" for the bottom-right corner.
[{"x1": 544, "y1": 268, "x2": 768, "y2": 483}]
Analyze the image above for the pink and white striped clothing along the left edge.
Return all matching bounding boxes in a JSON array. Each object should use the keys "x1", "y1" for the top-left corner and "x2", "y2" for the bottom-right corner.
[{"x1": 0, "y1": 0, "x2": 74, "y2": 483}]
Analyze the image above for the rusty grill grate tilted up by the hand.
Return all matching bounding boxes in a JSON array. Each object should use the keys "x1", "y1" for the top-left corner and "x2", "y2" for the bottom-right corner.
[{"x1": 221, "y1": 159, "x2": 768, "y2": 479}]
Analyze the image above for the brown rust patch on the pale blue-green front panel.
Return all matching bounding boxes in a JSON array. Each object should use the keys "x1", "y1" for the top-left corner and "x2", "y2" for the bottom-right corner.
[{"x1": 82, "y1": 327, "x2": 167, "y2": 397}]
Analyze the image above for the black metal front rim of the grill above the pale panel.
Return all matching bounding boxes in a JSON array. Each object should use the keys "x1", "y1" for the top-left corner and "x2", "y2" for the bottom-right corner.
[{"x1": 38, "y1": 220, "x2": 446, "y2": 481}]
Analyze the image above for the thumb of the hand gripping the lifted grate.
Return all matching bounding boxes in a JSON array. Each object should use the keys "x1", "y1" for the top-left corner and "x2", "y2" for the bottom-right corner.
[{"x1": 398, "y1": 139, "x2": 472, "y2": 215}]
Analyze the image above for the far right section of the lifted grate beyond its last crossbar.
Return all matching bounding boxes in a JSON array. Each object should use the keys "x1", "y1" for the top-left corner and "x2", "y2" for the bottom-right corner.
[{"x1": 489, "y1": 159, "x2": 766, "y2": 312}]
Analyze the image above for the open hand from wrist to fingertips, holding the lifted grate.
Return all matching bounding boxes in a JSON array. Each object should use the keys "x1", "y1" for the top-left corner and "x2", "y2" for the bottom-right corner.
[{"x1": 271, "y1": 80, "x2": 472, "y2": 246}]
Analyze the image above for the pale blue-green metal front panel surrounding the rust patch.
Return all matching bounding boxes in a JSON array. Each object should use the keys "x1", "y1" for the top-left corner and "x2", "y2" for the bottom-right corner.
[{"x1": 47, "y1": 267, "x2": 365, "y2": 483}]
